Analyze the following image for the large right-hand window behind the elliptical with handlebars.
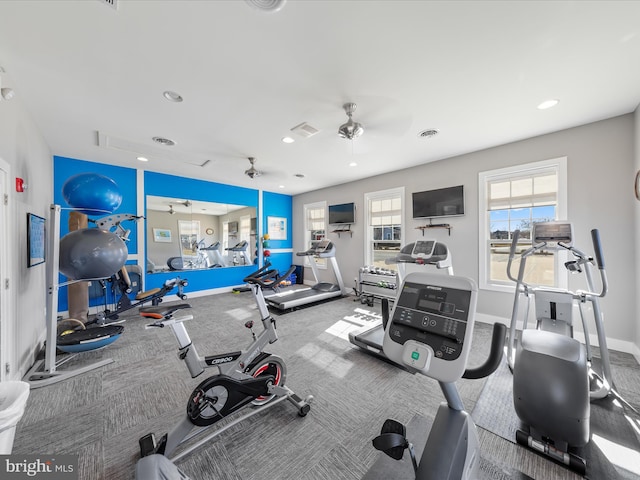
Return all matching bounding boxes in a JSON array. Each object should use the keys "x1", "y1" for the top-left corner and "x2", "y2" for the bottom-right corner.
[{"x1": 478, "y1": 158, "x2": 567, "y2": 291}]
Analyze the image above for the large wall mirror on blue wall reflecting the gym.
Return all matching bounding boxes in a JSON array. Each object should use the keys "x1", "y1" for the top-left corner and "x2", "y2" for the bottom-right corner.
[{"x1": 146, "y1": 195, "x2": 257, "y2": 273}]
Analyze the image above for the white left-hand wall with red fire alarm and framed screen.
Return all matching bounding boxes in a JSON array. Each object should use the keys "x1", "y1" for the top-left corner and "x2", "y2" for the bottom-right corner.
[{"x1": 0, "y1": 74, "x2": 53, "y2": 380}]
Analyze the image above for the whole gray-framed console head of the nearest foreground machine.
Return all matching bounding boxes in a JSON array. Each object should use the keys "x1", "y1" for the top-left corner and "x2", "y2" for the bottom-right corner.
[{"x1": 383, "y1": 272, "x2": 478, "y2": 382}]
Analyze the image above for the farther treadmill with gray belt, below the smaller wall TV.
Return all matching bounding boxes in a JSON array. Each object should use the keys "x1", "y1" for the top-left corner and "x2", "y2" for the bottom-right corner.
[{"x1": 265, "y1": 240, "x2": 344, "y2": 310}]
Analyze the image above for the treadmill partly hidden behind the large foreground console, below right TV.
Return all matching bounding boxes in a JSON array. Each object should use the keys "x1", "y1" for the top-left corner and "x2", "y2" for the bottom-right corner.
[{"x1": 349, "y1": 240, "x2": 453, "y2": 361}]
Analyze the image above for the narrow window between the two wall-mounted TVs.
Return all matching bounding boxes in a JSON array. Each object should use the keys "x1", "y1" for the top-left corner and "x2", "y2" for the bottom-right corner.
[{"x1": 364, "y1": 188, "x2": 404, "y2": 270}]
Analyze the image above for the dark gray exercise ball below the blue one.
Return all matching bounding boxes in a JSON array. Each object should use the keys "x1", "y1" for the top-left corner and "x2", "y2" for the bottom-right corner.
[{"x1": 59, "y1": 228, "x2": 128, "y2": 280}]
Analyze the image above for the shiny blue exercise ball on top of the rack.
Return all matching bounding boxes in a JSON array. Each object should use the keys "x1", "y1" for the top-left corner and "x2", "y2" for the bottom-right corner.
[{"x1": 62, "y1": 173, "x2": 122, "y2": 215}]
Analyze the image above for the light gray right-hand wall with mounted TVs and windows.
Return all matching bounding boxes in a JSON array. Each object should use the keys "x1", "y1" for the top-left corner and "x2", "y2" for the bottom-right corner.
[{"x1": 293, "y1": 114, "x2": 640, "y2": 351}]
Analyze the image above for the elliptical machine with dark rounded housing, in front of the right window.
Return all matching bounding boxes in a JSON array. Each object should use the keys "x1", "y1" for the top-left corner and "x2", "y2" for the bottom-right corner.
[{"x1": 507, "y1": 222, "x2": 613, "y2": 475}]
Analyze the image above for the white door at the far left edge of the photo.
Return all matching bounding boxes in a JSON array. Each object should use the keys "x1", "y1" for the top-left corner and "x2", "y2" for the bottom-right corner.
[{"x1": 0, "y1": 158, "x2": 15, "y2": 381}]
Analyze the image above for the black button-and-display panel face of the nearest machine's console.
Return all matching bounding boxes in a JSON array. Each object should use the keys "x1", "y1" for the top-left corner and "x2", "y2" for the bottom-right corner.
[{"x1": 389, "y1": 282, "x2": 471, "y2": 360}]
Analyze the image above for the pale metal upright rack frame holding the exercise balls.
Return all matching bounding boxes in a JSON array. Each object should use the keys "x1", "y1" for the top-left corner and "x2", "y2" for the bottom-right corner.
[{"x1": 24, "y1": 204, "x2": 124, "y2": 388}]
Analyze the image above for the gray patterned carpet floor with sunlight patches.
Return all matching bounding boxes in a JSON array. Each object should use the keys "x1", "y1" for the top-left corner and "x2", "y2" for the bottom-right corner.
[{"x1": 13, "y1": 292, "x2": 640, "y2": 480}]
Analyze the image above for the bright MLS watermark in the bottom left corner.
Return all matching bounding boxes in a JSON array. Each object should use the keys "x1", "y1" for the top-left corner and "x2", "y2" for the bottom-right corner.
[{"x1": 0, "y1": 455, "x2": 78, "y2": 480}]
